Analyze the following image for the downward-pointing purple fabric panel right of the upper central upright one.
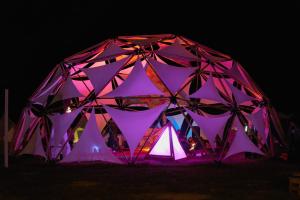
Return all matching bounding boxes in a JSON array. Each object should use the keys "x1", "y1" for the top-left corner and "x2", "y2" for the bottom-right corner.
[{"x1": 149, "y1": 59, "x2": 195, "y2": 94}]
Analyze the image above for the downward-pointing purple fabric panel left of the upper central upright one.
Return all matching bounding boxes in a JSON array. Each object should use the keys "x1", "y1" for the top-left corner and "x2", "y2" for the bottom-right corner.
[{"x1": 81, "y1": 58, "x2": 127, "y2": 95}]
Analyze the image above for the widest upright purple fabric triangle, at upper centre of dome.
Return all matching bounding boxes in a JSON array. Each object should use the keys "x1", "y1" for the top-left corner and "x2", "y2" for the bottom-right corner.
[{"x1": 105, "y1": 61, "x2": 163, "y2": 97}]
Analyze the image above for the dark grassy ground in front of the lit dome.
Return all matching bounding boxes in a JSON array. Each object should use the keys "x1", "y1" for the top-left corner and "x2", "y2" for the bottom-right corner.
[{"x1": 0, "y1": 157, "x2": 300, "y2": 200}]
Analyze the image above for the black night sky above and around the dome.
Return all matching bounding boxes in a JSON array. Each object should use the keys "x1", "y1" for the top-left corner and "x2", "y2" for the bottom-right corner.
[{"x1": 0, "y1": 0, "x2": 300, "y2": 121}]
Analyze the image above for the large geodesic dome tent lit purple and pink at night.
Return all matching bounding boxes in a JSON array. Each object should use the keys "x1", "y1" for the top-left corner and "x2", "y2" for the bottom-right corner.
[{"x1": 13, "y1": 34, "x2": 282, "y2": 163}]
